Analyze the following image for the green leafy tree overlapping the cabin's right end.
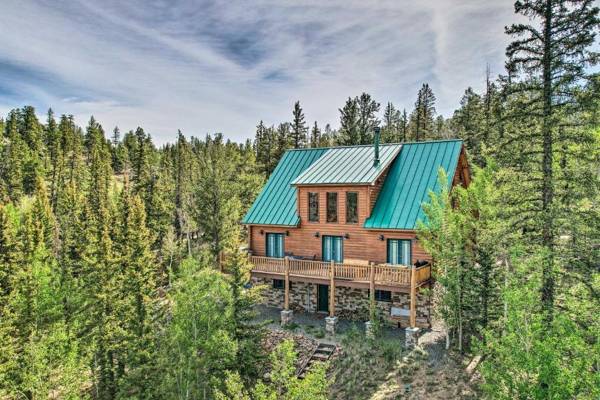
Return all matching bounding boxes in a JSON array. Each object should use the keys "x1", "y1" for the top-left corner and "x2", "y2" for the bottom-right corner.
[{"x1": 418, "y1": 167, "x2": 503, "y2": 350}]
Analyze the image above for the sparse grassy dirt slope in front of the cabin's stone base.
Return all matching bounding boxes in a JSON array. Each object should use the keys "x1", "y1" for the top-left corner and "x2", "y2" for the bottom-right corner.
[{"x1": 256, "y1": 311, "x2": 479, "y2": 400}]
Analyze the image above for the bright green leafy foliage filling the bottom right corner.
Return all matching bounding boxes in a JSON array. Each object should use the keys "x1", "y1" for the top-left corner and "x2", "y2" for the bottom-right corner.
[{"x1": 479, "y1": 252, "x2": 600, "y2": 399}]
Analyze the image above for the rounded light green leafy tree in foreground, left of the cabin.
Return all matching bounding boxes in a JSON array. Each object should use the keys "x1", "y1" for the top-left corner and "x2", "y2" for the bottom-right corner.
[{"x1": 156, "y1": 259, "x2": 238, "y2": 398}]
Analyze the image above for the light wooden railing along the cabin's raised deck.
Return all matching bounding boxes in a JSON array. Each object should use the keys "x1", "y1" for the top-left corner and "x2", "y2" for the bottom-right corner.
[{"x1": 250, "y1": 256, "x2": 431, "y2": 286}]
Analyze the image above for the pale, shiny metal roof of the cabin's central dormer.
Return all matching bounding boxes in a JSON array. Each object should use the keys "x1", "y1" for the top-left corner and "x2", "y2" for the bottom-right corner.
[{"x1": 292, "y1": 144, "x2": 402, "y2": 185}]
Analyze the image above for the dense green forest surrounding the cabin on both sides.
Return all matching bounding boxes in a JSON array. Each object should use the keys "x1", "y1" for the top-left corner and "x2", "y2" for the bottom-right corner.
[{"x1": 0, "y1": 0, "x2": 600, "y2": 400}]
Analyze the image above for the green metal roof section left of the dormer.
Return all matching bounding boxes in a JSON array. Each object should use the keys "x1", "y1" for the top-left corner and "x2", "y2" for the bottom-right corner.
[{"x1": 242, "y1": 149, "x2": 329, "y2": 226}]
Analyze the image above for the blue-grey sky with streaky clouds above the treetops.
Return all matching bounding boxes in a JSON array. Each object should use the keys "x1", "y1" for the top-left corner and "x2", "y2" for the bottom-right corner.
[{"x1": 0, "y1": 0, "x2": 515, "y2": 144}]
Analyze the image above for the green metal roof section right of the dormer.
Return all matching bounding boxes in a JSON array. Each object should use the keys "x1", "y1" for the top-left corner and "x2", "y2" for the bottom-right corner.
[{"x1": 364, "y1": 140, "x2": 462, "y2": 230}]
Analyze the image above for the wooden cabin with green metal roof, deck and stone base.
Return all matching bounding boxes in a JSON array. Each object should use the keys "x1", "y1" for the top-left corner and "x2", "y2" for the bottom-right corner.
[{"x1": 242, "y1": 133, "x2": 470, "y2": 338}]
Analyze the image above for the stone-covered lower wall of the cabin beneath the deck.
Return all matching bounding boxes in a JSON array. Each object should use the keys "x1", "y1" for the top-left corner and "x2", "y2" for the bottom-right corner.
[{"x1": 252, "y1": 276, "x2": 431, "y2": 328}]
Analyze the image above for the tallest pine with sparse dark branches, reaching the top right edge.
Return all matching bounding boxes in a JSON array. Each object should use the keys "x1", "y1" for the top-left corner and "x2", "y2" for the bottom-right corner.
[{"x1": 506, "y1": 0, "x2": 600, "y2": 326}]
